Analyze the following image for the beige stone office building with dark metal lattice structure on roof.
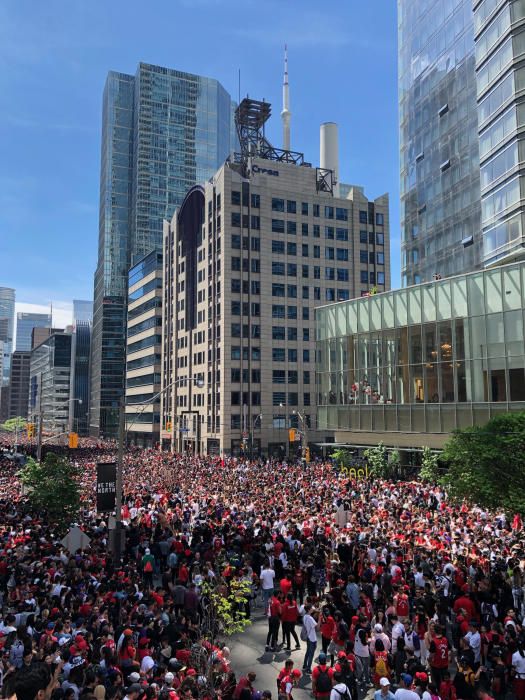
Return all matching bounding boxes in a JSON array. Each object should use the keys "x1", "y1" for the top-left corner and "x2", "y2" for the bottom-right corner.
[{"x1": 162, "y1": 99, "x2": 390, "y2": 455}]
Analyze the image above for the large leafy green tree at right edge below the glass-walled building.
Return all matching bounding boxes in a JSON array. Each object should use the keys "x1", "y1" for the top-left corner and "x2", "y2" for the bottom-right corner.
[{"x1": 441, "y1": 412, "x2": 525, "y2": 513}]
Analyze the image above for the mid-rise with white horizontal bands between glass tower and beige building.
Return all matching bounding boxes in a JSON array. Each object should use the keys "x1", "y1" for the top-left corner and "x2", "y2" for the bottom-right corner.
[{"x1": 126, "y1": 251, "x2": 162, "y2": 447}]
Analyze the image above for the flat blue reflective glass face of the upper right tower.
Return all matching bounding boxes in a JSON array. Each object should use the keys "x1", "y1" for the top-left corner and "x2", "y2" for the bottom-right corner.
[{"x1": 398, "y1": 0, "x2": 481, "y2": 286}]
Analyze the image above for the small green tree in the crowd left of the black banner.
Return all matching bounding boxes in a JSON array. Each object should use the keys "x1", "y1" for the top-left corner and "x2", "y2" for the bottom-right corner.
[{"x1": 19, "y1": 452, "x2": 80, "y2": 530}]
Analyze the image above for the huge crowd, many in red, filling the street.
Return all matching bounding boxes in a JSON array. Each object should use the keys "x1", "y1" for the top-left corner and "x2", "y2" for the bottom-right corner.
[{"x1": 0, "y1": 438, "x2": 525, "y2": 700}]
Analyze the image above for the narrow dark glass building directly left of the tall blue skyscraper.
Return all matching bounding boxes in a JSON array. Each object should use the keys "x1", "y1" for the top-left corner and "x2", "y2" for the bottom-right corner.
[{"x1": 69, "y1": 319, "x2": 91, "y2": 435}]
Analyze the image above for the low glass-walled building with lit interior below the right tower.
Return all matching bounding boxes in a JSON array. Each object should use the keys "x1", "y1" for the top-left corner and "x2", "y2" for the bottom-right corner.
[{"x1": 316, "y1": 264, "x2": 525, "y2": 433}]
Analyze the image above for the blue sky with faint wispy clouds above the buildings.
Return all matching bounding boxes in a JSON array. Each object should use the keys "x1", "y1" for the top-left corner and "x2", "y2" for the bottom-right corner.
[{"x1": 0, "y1": 0, "x2": 399, "y2": 320}]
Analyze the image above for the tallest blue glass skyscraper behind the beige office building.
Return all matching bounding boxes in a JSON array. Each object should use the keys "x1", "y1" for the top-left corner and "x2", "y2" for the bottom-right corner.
[{"x1": 90, "y1": 63, "x2": 233, "y2": 436}]
